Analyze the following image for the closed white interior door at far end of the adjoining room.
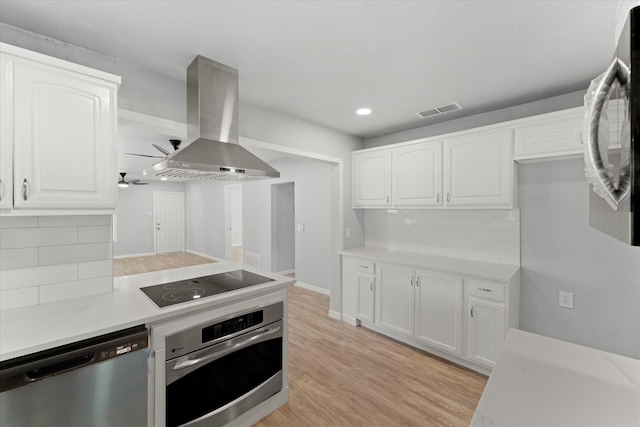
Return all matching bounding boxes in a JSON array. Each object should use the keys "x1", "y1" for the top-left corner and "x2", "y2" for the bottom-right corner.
[{"x1": 154, "y1": 191, "x2": 184, "y2": 254}]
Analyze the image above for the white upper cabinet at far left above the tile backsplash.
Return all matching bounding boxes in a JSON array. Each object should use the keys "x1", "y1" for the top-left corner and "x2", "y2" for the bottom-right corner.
[{"x1": 2, "y1": 45, "x2": 120, "y2": 210}]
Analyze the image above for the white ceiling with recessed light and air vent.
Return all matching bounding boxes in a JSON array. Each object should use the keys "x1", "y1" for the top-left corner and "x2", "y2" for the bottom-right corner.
[{"x1": 0, "y1": 0, "x2": 618, "y2": 179}]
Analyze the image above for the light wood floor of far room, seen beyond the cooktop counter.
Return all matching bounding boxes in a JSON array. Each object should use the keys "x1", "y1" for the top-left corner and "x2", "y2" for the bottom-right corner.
[{"x1": 113, "y1": 252, "x2": 216, "y2": 277}]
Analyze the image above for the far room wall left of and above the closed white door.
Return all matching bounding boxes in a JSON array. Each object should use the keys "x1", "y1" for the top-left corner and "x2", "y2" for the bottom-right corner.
[{"x1": 113, "y1": 181, "x2": 185, "y2": 257}]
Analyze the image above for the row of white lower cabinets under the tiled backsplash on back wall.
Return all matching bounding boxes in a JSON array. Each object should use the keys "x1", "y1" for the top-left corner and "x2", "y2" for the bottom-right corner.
[{"x1": 342, "y1": 257, "x2": 520, "y2": 373}]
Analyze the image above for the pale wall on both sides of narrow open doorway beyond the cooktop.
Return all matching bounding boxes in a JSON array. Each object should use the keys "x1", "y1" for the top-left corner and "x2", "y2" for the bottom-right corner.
[{"x1": 242, "y1": 159, "x2": 335, "y2": 290}]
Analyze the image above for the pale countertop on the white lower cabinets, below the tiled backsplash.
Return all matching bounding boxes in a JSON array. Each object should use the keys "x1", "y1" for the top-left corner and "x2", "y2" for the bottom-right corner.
[{"x1": 340, "y1": 247, "x2": 520, "y2": 283}]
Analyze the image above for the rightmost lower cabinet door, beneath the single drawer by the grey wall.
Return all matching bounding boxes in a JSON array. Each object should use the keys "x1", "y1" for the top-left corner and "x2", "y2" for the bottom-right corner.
[{"x1": 468, "y1": 296, "x2": 505, "y2": 367}]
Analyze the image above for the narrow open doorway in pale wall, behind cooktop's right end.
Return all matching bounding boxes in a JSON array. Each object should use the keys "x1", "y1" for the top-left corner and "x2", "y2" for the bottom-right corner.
[{"x1": 271, "y1": 182, "x2": 303, "y2": 274}]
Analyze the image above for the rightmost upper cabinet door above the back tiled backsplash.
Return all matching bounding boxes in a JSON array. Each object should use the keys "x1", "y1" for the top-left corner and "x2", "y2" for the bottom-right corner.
[{"x1": 443, "y1": 130, "x2": 513, "y2": 207}]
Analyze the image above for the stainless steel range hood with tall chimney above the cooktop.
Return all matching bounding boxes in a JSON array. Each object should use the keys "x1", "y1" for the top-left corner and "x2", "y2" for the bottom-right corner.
[{"x1": 143, "y1": 56, "x2": 280, "y2": 181}]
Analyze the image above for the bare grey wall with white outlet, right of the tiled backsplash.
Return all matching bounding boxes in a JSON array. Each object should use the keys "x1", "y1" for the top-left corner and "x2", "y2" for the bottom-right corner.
[{"x1": 519, "y1": 159, "x2": 640, "y2": 359}]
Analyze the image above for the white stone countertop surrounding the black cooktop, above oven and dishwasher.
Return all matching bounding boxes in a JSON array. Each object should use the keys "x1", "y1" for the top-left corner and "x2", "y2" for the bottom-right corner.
[{"x1": 0, "y1": 261, "x2": 294, "y2": 361}]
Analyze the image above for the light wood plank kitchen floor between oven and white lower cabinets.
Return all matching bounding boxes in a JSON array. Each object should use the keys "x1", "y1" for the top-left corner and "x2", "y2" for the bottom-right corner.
[{"x1": 254, "y1": 286, "x2": 487, "y2": 427}]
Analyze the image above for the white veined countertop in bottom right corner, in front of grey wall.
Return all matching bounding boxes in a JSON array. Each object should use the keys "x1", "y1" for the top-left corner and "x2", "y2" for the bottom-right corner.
[{"x1": 470, "y1": 329, "x2": 640, "y2": 427}]
